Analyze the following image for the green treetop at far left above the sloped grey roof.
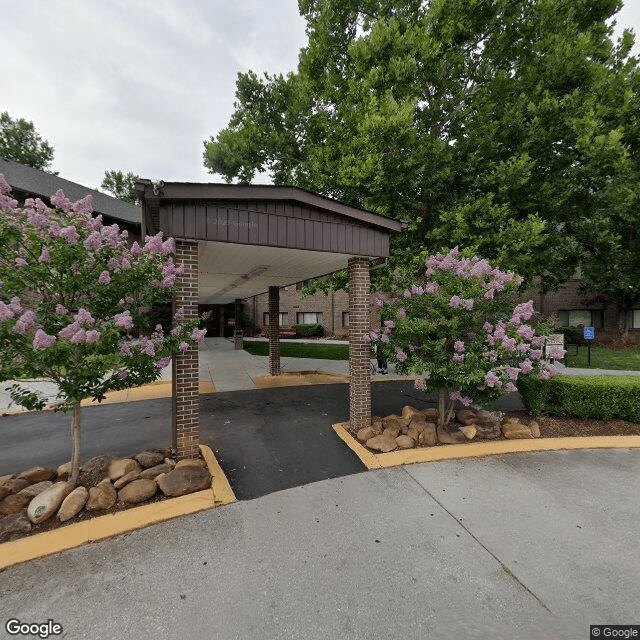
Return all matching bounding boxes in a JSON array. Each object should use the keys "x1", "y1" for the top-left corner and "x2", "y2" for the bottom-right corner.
[{"x1": 0, "y1": 111, "x2": 53, "y2": 170}]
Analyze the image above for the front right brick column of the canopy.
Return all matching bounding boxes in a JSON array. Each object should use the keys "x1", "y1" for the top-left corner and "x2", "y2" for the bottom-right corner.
[{"x1": 348, "y1": 258, "x2": 371, "y2": 430}]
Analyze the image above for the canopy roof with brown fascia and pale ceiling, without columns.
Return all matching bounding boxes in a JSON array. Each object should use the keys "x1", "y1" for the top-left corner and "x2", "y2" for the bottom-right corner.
[{"x1": 137, "y1": 180, "x2": 406, "y2": 304}]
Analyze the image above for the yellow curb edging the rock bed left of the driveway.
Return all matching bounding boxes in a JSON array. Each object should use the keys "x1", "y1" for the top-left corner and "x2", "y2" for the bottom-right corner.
[{"x1": 0, "y1": 444, "x2": 236, "y2": 571}]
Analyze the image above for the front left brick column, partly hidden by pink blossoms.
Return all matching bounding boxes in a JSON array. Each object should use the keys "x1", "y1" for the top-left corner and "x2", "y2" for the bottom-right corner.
[{"x1": 172, "y1": 240, "x2": 200, "y2": 460}]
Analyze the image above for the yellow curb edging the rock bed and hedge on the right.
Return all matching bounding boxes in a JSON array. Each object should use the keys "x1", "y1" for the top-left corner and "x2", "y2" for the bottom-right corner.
[{"x1": 333, "y1": 422, "x2": 640, "y2": 469}]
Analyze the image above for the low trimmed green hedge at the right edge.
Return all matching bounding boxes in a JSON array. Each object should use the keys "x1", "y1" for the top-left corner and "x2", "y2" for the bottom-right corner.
[{"x1": 518, "y1": 376, "x2": 640, "y2": 423}]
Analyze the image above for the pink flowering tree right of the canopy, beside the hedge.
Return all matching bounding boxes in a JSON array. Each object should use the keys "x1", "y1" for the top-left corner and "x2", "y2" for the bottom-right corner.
[{"x1": 369, "y1": 247, "x2": 564, "y2": 427}]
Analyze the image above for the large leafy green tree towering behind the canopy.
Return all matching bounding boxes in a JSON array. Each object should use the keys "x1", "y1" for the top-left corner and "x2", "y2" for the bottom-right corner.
[{"x1": 204, "y1": 0, "x2": 640, "y2": 296}]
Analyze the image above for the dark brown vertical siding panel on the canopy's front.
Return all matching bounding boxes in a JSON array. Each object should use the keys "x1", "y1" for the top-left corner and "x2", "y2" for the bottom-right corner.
[{"x1": 160, "y1": 201, "x2": 389, "y2": 257}]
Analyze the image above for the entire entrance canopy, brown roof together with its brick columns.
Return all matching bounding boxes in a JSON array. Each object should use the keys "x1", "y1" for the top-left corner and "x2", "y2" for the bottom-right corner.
[{"x1": 136, "y1": 180, "x2": 403, "y2": 457}]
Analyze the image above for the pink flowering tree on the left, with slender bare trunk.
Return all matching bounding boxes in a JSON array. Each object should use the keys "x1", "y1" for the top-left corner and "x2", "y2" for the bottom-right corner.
[{"x1": 0, "y1": 174, "x2": 205, "y2": 484}]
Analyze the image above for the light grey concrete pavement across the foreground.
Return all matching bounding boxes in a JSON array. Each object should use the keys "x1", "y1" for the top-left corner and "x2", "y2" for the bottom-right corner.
[{"x1": 0, "y1": 450, "x2": 640, "y2": 640}]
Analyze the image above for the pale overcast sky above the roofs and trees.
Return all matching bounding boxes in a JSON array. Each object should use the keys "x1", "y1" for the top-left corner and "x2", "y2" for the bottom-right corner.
[{"x1": 0, "y1": 0, "x2": 640, "y2": 194}]
